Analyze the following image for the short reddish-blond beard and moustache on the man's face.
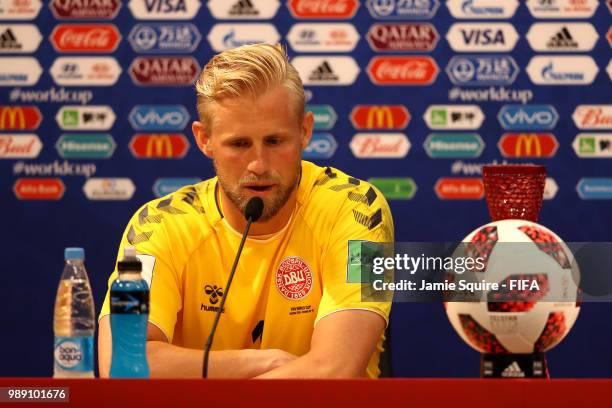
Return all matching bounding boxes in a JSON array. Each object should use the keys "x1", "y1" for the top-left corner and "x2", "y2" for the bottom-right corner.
[{"x1": 213, "y1": 159, "x2": 302, "y2": 222}]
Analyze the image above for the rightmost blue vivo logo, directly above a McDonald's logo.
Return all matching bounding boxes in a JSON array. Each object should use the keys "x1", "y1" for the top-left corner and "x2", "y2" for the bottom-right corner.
[{"x1": 497, "y1": 105, "x2": 559, "y2": 130}]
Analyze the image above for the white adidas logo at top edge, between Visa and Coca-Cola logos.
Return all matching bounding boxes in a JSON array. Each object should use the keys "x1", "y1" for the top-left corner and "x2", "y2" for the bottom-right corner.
[{"x1": 207, "y1": 0, "x2": 280, "y2": 20}]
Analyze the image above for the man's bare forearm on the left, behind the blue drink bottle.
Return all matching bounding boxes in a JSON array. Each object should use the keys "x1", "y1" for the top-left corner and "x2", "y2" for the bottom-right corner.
[{"x1": 98, "y1": 315, "x2": 296, "y2": 378}]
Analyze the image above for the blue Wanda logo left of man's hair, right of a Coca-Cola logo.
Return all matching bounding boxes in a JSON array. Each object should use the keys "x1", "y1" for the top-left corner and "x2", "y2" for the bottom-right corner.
[{"x1": 128, "y1": 23, "x2": 202, "y2": 54}]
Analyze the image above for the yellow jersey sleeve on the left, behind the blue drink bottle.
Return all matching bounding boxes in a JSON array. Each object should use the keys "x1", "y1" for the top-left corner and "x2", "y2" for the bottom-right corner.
[{"x1": 98, "y1": 203, "x2": 182, "y2": 343}]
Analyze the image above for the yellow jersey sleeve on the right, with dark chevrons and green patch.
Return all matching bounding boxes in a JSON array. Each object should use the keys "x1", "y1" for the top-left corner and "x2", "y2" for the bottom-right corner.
[{"x1": 315, "y1": 179, "x2": 393, "y2": 324}]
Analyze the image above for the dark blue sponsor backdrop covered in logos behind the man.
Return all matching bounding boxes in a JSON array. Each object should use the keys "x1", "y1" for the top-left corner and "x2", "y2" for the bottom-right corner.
[{"x1": 0, "y1": 0, "x2": 612, "y2": 377}]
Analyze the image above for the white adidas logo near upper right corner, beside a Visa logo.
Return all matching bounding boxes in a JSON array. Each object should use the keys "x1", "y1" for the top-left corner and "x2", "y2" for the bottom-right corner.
[{"x1": 527, "y1": 23, "x2": 599, "y2": 52}]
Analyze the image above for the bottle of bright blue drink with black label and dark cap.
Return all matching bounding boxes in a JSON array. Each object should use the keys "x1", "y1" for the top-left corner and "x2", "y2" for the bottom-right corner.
[{"x1": 110, "y1": 247, "x2": 149, "y2": 378}]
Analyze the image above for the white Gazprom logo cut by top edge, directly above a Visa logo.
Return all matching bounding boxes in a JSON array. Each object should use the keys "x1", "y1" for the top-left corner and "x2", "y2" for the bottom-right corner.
[{"x1": 446, "y1": 0, "x2": 519, "y2": 19}]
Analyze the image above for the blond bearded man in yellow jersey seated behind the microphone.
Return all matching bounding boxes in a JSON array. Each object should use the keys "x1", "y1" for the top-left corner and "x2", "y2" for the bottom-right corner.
[{"x1": 98, "y1": 44, "x2": 393, "y2": 378}]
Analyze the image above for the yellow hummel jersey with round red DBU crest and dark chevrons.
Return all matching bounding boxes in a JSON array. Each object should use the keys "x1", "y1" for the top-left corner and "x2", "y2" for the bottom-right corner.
[{"x1": 100, "y1": 161, "x2": 393, "y2": 377}]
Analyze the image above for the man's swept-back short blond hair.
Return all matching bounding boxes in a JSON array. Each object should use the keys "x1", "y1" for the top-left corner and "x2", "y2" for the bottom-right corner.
[{"x1": 195, "y1": 44, "x2": 306, "y2": 134}]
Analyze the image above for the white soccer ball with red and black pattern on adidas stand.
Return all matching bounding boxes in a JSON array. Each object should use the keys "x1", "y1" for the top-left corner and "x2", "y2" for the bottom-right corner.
[{"x1": 445, "y1": 220, "x2": 580, "y2": 354}]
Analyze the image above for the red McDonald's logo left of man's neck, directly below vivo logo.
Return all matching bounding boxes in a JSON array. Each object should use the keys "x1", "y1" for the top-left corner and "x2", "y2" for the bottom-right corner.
[{"x1": 130, "y1": 133, "x2": 190, "y2": 159}]
